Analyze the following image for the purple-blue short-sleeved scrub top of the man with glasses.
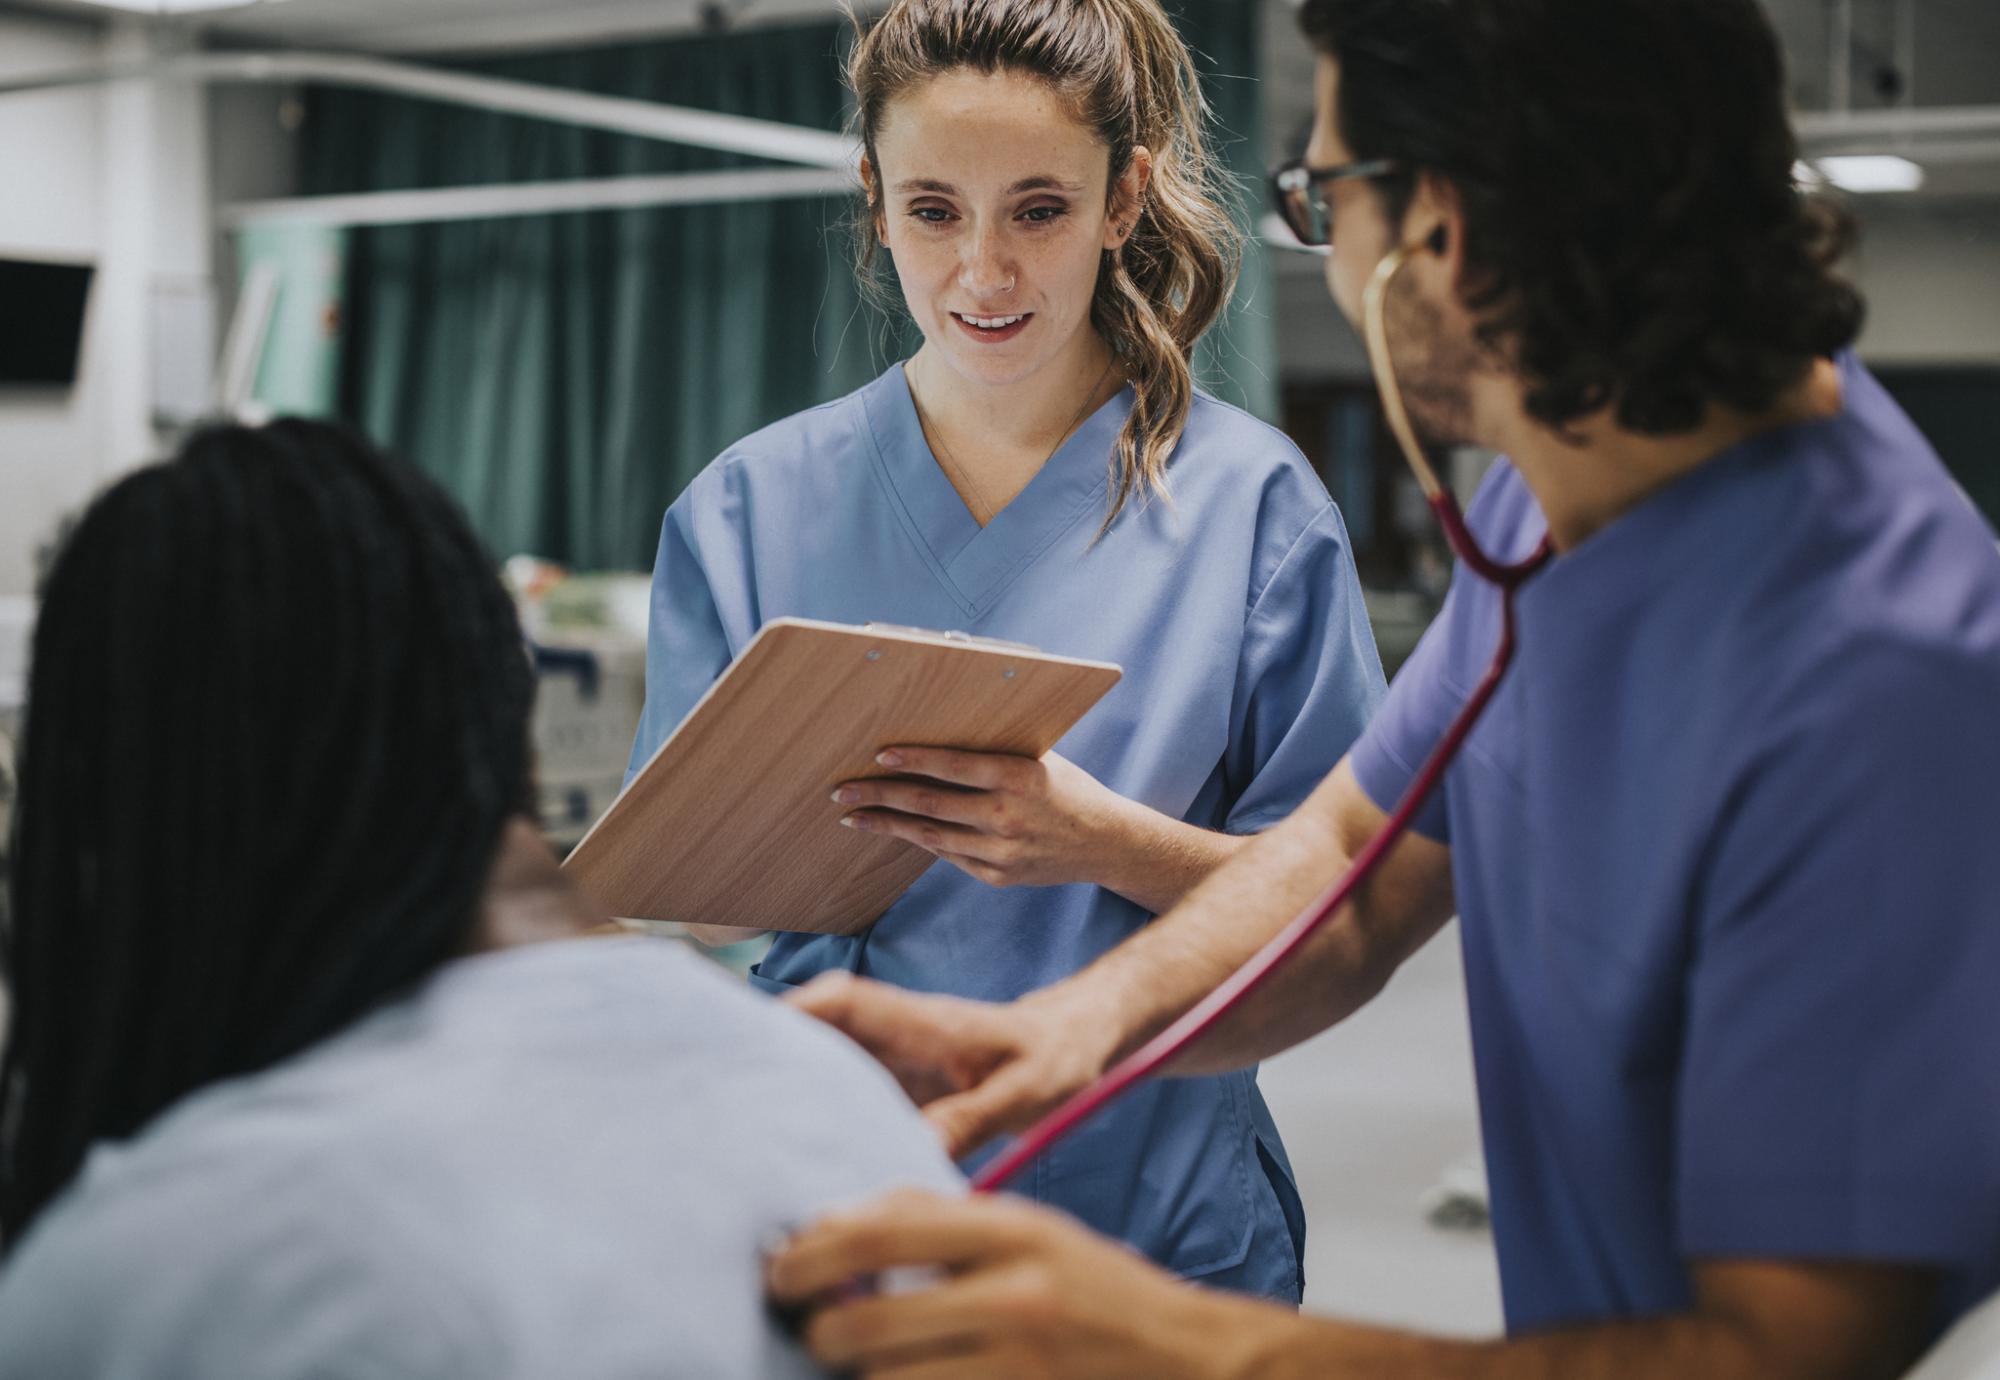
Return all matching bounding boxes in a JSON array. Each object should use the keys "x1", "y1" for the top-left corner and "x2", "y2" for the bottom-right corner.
[{"x1": 1354, "y1": 358, "x2": 2000, "y2": 1330}]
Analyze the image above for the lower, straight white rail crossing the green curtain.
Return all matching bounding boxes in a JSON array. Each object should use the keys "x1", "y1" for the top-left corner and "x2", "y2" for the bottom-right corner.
[{"x1": 218, "y1": 168, "x2": 856, "y2": 230}]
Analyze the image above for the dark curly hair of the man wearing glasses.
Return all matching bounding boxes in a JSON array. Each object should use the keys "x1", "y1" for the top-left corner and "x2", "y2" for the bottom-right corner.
[{"x1": 1300, "y1": 0, "x2": 1862, "y2": 434}]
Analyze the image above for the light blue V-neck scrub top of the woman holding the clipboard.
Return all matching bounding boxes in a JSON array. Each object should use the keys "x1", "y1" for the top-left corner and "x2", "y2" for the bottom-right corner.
[{"x1": 632, "y1": 366, "x2": 1382, "y2": 1300}]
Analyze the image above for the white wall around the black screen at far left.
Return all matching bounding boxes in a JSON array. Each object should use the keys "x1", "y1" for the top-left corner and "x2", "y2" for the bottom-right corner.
[{"x1": 0, "y1": 10, "x2": 212, "y2": 596}]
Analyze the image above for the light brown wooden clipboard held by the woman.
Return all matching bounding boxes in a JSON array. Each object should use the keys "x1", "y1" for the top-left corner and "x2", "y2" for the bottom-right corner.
[{"x1": 562, "y1": 618, "x2": 1124, "y2": 934}]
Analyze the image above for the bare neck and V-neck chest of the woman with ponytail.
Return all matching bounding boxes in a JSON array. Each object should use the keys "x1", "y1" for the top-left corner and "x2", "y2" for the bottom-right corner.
[{"x1": 904, "y1": 330, "x2": 1124, "y2": 526}]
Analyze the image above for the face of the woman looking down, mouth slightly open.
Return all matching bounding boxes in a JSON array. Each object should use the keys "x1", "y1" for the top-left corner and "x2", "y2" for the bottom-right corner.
[{"x1": 870, "y1": 70, "x2": 1138, "y2": 386}]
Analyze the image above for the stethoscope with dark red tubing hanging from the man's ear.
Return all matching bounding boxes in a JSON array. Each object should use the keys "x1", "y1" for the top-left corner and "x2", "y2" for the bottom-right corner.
[{"x1": 972, "y1": 244, "x2": 1552, "y2": 1194}]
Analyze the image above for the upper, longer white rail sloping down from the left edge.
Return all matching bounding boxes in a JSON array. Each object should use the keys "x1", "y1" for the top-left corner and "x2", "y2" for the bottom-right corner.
[{"x1": 0, "y1": 52, "x2": 860, "y2": 168}]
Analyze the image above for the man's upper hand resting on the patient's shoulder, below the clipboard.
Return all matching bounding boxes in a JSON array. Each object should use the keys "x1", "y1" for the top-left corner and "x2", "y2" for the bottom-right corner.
[{"x1": 786, "y1": 972, "x2": 1116, "y2": 1158}]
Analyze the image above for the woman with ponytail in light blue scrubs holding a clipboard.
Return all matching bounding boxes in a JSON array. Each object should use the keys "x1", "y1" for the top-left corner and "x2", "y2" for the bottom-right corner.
[{"x1": 632, "y1": 0, "x2": 1382, "y2": 1302}]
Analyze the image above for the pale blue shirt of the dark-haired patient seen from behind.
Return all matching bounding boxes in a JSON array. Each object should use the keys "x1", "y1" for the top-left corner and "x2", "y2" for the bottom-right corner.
[{"x1": 0, "y1": 940, "x2": 962, "y2": 1380}]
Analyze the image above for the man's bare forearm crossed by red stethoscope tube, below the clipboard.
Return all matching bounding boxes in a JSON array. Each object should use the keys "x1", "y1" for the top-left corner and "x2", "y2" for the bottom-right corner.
[{"x1": 1036, "y1": 766, "x2": 1450, "y2": 1074}]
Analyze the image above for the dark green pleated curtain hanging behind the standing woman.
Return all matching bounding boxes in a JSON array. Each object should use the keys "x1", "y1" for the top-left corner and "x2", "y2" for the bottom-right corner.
[{"x1": 304, "y1": 0, "x2": 1274, "y2": 570}]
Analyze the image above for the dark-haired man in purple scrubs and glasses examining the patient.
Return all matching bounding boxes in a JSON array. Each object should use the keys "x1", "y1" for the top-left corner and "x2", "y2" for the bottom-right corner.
[{"x1": 772, "y1": 0, "x2": 2000, "y2": 1380}]
